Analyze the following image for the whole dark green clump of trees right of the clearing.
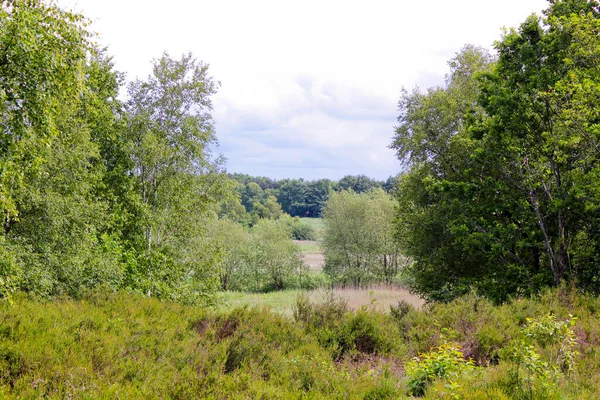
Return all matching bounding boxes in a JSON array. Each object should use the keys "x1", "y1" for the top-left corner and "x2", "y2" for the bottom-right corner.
[{"x1": 391, "y1": 0, "x2": 600, "y2": 301}]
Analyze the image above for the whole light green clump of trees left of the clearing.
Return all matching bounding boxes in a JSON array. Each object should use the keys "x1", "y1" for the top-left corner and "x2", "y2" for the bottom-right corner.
[{"x1": 0, "y1": 0, "x2": 230, "y2": 302}]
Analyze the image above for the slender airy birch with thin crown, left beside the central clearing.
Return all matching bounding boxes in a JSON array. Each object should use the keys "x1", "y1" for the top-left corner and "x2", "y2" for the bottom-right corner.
[{"x1": 127, "y1": 53, "x2": 225, "y2": 296}]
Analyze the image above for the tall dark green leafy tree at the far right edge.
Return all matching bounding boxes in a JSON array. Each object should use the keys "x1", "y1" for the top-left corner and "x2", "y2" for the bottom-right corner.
[{"x1": 472, "y1": 0, "x2": 600, "y2": 286}]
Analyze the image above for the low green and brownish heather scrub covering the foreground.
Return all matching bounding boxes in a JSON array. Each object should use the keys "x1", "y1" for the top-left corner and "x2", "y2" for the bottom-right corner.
[{"x1": 0, "y1": 288, "x2": 600, "y2": 399}]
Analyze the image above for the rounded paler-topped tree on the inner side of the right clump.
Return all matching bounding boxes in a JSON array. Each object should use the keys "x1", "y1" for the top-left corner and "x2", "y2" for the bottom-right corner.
[{"x1": 391, "y1": 46, "x2": 504, "y2": 300}]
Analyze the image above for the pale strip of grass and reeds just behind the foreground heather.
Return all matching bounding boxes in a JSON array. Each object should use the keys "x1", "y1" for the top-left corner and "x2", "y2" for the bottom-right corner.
[{"x1": 221, "y1": 286, "x2": 424, "y2": 316}]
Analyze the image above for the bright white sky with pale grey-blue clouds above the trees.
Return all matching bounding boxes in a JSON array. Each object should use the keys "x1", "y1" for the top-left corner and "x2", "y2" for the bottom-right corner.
[{"x1": 55, "y1": 0, "x2": 547, "y2": 180}]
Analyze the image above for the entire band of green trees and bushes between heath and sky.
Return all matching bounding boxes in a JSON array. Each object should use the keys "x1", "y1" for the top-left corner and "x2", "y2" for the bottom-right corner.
[{"x1": 0, "y1": 0, "x2": 600, "y2": 302}]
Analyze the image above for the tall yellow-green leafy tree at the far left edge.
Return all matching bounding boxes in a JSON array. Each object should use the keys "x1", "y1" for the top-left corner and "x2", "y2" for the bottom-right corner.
[{"x1": 0, "y1": 1, "x2": 132, "y2": 296}]
